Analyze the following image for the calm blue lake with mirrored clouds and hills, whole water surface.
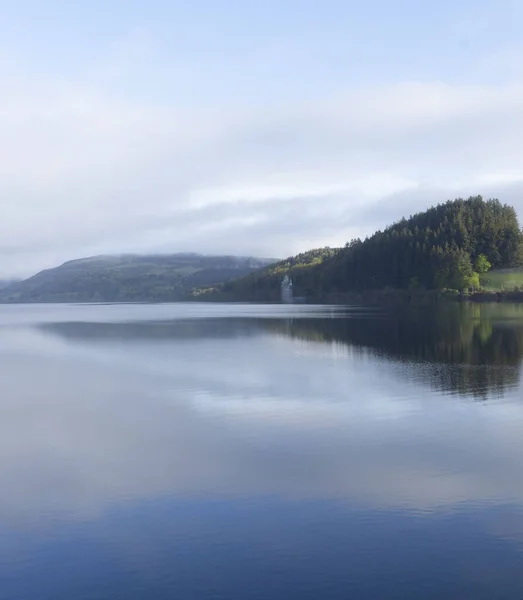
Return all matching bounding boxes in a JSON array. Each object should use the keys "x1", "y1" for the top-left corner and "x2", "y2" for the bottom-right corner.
[{"x1": 0, "y1": 303, "x2": 523, "y2": 600}]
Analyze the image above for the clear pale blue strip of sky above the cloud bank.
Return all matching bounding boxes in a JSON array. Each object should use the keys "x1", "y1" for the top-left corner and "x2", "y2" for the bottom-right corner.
[{"x1": 0, "y1": 0, "x2": 523, "y2": 96}]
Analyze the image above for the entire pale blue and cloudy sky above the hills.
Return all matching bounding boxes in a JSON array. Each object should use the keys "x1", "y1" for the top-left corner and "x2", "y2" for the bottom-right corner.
[{"x1": 0, "y1": 0, "x2": 523, "y2": 278}]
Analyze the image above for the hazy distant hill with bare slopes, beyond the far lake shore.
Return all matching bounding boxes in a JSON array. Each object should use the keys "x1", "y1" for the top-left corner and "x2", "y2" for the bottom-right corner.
[{"x1": 0, "y1": 253, "x2": 274, "y2": 303}]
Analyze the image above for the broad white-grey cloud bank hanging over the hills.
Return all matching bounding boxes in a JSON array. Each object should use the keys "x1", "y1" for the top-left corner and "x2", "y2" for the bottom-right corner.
[{"x1": 0, "y1": 56, "x2": 523, "y2": 275}]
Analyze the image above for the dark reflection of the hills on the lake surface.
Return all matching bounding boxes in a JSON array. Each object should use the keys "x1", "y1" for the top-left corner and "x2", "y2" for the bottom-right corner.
[{"x1": 42, "y1": 304, "x2": 523, "y2": 397}]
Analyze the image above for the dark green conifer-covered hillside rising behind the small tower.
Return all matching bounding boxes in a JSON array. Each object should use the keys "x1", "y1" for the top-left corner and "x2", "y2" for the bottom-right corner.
[{"x1": 202, "y1": 196, "x2": 522, "y2": 300}]
